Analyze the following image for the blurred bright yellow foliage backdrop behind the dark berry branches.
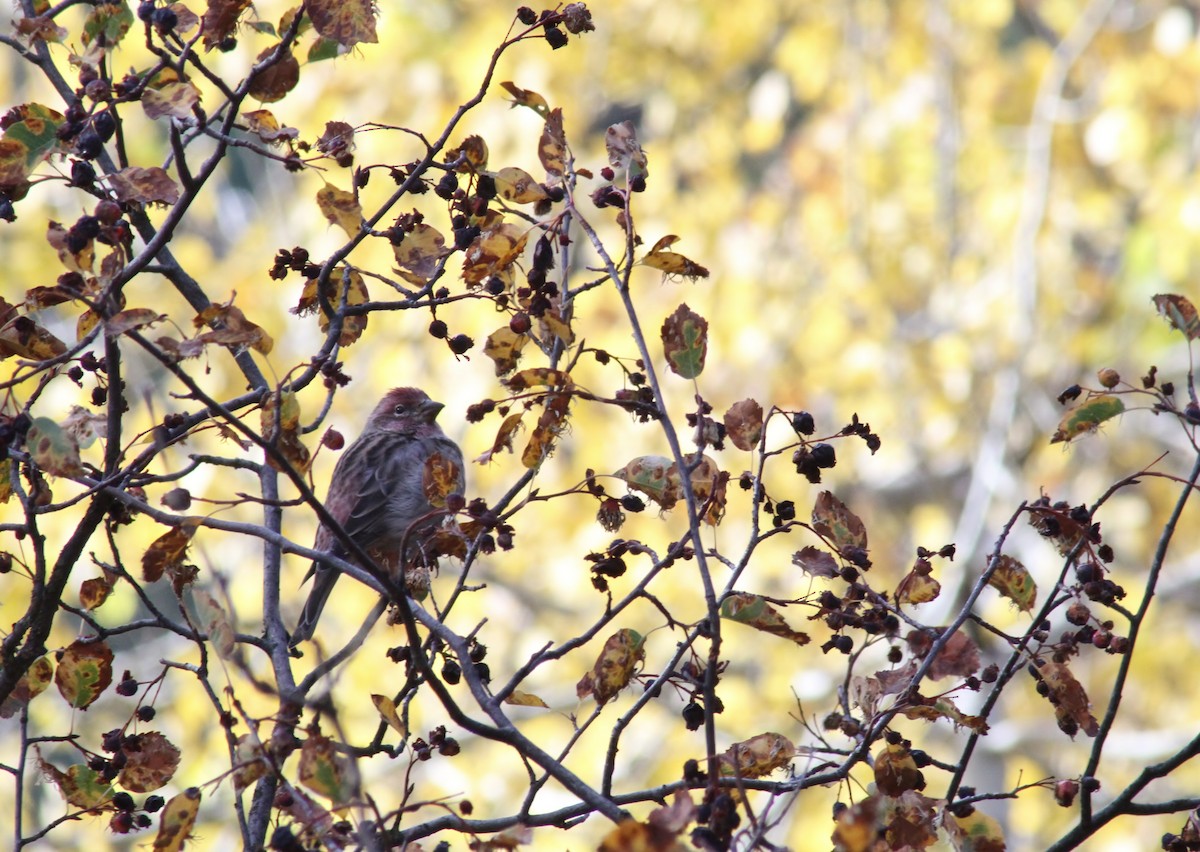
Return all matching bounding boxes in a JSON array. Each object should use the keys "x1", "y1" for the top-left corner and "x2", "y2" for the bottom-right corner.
[{"x1": 7, "y1": 0, "x2": 1200, "y2": 850}]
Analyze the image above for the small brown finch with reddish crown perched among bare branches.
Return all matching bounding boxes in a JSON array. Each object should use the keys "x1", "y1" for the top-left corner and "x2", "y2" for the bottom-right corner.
[{"x1": 292, "y1": 388, "x2": 464, "y2": 646}]
